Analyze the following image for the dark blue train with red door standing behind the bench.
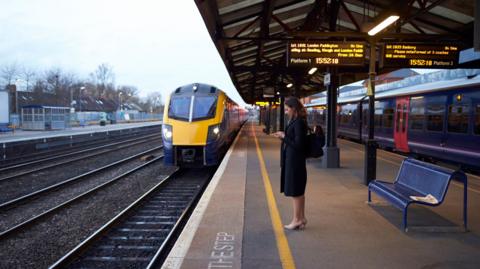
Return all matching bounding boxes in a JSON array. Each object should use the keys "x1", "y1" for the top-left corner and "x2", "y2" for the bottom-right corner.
[{"x1": 307, "y1": 74, "x2": 480, "y2": 171}]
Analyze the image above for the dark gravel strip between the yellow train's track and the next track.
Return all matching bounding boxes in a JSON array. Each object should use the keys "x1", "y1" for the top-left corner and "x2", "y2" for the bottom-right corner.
[{"x1": 0, "y1": 161, "x2": 176, "y2": 268}]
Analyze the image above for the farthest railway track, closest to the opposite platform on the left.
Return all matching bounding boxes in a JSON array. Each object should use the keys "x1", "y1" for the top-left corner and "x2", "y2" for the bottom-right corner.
[{"x1": 0, "y1": 134, "x2": 160, "y2": 182}]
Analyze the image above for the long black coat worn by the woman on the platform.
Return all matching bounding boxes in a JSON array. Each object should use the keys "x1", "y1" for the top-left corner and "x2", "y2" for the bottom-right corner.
[{"x1": 280, "y1": 116, "x2": 307, "y2": 196}]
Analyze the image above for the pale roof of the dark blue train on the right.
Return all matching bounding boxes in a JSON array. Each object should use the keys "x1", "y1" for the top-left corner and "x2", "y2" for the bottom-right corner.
[{"x1": 306, "y1": 69, "x2": 480, "y2": 107}]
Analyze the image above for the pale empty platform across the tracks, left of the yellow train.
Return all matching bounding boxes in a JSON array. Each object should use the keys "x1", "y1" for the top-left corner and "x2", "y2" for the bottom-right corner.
[{"x1": 0, "y1": 121, "x2": 162, "y2": 143}]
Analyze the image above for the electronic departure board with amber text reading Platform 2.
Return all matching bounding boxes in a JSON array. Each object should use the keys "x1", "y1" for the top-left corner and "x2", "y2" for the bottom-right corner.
[{"x1": 382, "y1": 43, "x2": 459, "y2": 68}]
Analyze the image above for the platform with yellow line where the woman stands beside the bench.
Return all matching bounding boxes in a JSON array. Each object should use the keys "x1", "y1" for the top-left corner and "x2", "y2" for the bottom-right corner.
[{"x1": 163, "y1": 123, "x2": 480, "y2": 269}]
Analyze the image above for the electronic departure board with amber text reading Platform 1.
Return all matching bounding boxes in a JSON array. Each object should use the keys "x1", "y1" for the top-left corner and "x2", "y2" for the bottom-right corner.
[{"x1": 287, "y1": 41, "x2": 365, "y2": 67}]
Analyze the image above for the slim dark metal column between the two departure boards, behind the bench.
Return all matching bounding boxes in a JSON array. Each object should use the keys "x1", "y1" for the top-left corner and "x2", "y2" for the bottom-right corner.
[{"x1": 363, "y1": 40, "x2": 377, "y2": 185}]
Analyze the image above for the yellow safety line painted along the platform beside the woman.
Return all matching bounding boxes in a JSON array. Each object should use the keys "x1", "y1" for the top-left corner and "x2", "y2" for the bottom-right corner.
[{"x1": 252, "y1": 124, "x2": 296, "y2": 269}]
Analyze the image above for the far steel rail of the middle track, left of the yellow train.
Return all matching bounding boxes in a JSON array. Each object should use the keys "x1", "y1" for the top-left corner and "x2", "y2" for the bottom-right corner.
[{"x1": 0, "y1": 146, "x2": 163, "y2": 210}]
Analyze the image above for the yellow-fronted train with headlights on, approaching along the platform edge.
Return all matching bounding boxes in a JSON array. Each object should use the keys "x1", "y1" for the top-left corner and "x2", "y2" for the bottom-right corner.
[{"x1": 162, "y1": 83, "x2": 248, "y2": 166}]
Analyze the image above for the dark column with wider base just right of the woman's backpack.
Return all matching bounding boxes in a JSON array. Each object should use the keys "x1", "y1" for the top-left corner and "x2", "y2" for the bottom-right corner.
[{"x1": 322, "y1": 68, "x2": 340, "y2": 168}]
